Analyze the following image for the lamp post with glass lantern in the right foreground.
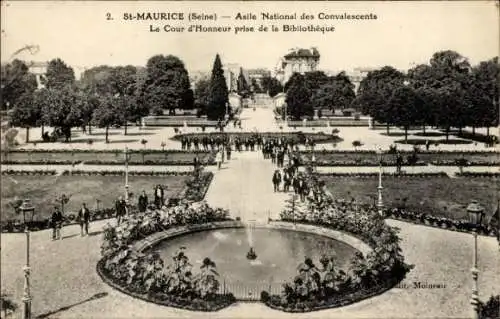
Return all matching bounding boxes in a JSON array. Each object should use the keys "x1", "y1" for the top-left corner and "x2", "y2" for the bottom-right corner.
[{"x1": 467, "y1": 200, "x2": 484, "y2": 319}]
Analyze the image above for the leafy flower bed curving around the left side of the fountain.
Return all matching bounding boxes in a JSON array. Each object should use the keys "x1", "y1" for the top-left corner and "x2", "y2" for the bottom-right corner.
[{"x1": 97, "y1": 202, "x2": 239, "y2": 311}]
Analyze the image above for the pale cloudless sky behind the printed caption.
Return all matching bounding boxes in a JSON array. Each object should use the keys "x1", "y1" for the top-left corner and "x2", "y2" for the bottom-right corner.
[{"x1": 1, "y1": 1, "x2": 500, "y2": 77}]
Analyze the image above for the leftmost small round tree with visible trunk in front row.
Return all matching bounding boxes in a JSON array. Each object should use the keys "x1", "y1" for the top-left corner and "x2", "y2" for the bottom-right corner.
[{"x1": 11, "y1": 93, "x2": 41, "y2": 143}]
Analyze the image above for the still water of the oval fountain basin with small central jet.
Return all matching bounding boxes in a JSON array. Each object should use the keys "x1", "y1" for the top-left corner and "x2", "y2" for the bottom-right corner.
[{"x1": 152, "y1": 228, "x2": 357, "y2": 287}]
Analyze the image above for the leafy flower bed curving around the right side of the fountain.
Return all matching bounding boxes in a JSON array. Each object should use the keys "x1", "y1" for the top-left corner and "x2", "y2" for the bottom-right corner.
[{"x1": 261, "y1": 171, "x2": 412, "y2": 312}]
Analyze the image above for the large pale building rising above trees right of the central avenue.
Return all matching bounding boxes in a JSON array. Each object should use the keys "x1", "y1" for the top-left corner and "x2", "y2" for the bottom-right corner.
[{"x1": 275, "y1": 48, "x2": 320, "y2": 85}]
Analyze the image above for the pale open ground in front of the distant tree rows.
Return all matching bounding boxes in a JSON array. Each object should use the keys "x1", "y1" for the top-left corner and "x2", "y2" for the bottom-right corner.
[{"x1": 5, "y1": 107, "x2": 498, "y2": 151}]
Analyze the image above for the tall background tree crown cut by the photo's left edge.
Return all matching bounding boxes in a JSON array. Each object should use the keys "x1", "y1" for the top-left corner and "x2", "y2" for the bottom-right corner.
[{"x1": 0, "y1": 59, "x2": 37, "y2": 110}]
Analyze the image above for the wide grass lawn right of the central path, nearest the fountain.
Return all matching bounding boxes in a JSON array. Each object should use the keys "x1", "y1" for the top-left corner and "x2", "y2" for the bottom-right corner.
[{"x1": 321, "y1": 176, "x2": 499, "y2": 220}]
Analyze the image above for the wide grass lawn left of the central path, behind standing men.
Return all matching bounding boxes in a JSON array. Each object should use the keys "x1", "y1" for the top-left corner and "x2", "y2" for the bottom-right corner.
[{"x1": 0, "y1": 175, "x2": 189, "y2": 220}]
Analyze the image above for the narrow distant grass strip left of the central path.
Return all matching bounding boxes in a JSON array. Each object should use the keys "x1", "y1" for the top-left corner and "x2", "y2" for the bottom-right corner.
[{"x1": 2, "y1": 151, "x2": 214, "y2": 165}]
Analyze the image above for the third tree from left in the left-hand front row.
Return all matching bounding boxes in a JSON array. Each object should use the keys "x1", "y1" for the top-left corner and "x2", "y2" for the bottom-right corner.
[{"x1": 93, "y1": 95, "x2": 125, "y2": 143}]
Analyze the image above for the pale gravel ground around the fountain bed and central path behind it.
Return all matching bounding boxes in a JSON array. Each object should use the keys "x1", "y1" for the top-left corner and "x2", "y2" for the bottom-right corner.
[{"x1": 1, "y1": 152, "x2": 500, "y2": 318}]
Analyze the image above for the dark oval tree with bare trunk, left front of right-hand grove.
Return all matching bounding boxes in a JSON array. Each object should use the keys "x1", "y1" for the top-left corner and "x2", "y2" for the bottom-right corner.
[{"x1": 388, "y1": 85, "x2": 420, "y2": 141}]
